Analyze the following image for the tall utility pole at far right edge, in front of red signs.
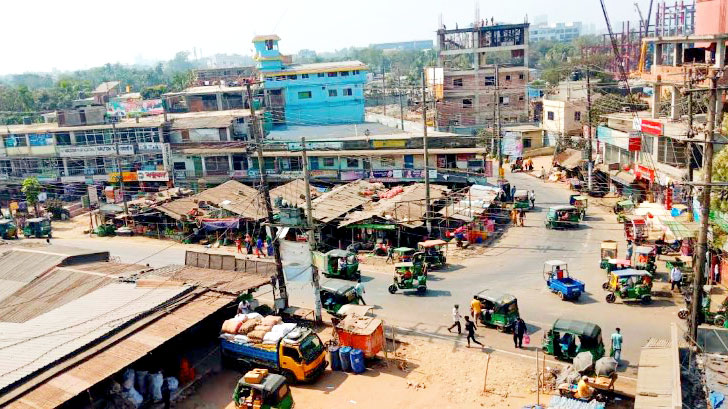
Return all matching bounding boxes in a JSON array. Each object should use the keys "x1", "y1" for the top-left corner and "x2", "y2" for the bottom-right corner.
[{"x1": 690, "y1": 70, "x2": 718, "y2": 342}]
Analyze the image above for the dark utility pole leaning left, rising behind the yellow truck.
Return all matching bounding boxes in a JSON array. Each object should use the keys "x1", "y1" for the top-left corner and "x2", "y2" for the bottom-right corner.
[{"x1": 245, "y1": 82, "x2": 288, "y2": 308}]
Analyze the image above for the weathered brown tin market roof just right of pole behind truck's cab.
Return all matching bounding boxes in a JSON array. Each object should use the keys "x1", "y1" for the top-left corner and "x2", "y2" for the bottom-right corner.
[{"x1": 312, "y1": 180, "x2": 382, "y2": 223}]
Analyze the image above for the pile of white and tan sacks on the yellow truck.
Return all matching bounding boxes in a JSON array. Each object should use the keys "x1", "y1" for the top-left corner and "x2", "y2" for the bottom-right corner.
[{"x1": 220, "y1": 313, "x2": 296, "y2": 346}]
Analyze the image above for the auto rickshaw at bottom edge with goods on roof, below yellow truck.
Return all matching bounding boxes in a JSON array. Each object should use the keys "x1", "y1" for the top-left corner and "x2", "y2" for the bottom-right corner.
[{"x1": 233, "y1": 370, "x2": 294, "y2": 409}]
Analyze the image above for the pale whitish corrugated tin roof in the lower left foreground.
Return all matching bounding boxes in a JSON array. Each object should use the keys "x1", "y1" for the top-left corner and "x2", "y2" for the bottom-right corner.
[{"x1": 0, "y1": 283, "x2": 189, "y2": 394}]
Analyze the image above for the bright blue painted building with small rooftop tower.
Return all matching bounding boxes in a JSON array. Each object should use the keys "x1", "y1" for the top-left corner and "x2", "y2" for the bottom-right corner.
[{"x1": 253, "y1": 35, "x2": 368, "y2": 125}]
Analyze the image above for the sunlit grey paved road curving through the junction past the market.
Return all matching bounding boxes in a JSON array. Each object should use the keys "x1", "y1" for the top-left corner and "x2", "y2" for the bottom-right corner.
[{"x1": 54, "y1": 170, "x2": 679, "y2": 374}]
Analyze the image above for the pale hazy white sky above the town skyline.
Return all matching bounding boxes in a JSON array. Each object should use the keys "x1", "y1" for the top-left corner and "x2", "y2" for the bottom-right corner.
[{"x1": 0, "y1": 0, "x2": 649, "y2": 74}]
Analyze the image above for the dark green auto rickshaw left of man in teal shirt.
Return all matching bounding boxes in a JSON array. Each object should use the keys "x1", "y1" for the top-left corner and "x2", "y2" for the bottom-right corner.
[{"x1": 542, "y1": 318, "x2": 605, "y2": 362}]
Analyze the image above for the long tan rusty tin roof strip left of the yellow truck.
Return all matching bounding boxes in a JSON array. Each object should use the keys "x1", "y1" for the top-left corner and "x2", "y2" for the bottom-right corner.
[{"x1": 6, "y1": 292, "x2": 234, "y2": 409}]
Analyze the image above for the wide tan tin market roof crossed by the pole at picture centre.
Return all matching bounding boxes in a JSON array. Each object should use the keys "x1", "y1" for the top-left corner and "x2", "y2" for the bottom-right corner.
[{"x1": 339, "y1": 183, "x2": 450, "y2": 228}]
